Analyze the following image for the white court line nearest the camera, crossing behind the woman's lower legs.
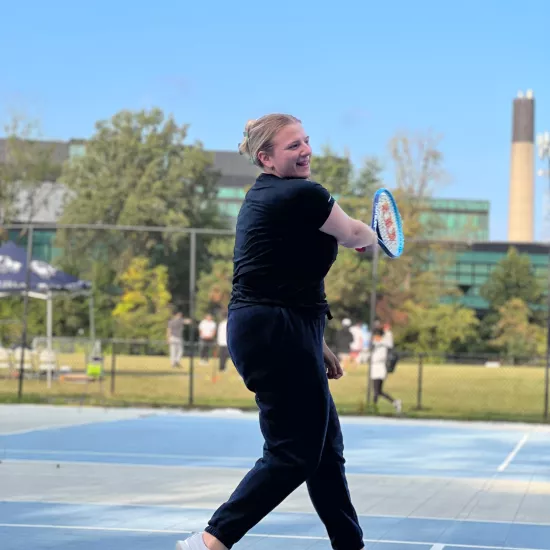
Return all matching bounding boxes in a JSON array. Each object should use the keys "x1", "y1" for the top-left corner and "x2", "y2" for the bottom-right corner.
[{"x1": 0, "y1": 523, "x2": 544, "y2": 550}]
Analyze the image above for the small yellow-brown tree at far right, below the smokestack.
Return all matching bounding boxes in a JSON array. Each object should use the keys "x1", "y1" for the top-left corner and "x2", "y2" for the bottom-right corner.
[{"x1": 489, "y1": 298, "x2": 546, "y2": 362}]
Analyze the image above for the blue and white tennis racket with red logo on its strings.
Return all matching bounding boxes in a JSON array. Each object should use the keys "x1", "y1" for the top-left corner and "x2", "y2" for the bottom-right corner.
[{"x1": 355, "y1": 188, "x2": 405, "y2": 258}]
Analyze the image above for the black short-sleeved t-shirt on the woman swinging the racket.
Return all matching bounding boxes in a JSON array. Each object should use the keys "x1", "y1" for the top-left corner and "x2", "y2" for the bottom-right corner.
[{"x1": 229, "y1": 174, "x2": 338, "y2": 320}]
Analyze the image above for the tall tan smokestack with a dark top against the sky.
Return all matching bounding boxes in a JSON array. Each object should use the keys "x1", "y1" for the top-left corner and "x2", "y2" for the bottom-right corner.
[{"x1": 508, "y1": 90, "x2": 535, "y2": 242}]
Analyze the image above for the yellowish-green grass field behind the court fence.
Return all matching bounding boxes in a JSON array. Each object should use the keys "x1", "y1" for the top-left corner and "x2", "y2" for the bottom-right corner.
[{"x1": 0, "y1": 354, "x2": 545, "y2": 422}]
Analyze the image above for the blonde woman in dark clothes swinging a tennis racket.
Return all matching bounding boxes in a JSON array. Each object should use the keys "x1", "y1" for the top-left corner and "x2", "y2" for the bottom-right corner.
[{"x1": 177, "y1": 114, "x2": 377, "y2": 550}]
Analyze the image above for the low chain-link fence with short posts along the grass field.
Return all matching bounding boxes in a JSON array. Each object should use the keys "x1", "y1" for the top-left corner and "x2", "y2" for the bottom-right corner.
[{"x1": 0, "y1": 339, "x2": 549, "y2": 422}]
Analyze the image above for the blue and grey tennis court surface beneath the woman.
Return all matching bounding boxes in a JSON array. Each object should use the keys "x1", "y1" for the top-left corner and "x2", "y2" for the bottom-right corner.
[{"x1": 0, "y1": 405, "x2": 550, "y2": 550}]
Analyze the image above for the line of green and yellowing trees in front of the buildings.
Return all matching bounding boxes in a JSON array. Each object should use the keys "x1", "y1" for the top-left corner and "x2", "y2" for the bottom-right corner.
[{"x1": 0, "y1": 109, "x2": 546, "y2": 364}]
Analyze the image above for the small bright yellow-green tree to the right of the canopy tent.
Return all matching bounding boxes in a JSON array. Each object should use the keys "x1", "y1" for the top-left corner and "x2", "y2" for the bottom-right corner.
[{"x1": 113, "y1": 257, "x2": 172, "y2": 340}]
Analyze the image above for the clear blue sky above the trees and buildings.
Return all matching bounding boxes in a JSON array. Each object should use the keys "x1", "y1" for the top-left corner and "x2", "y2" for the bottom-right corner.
[{"x1": 0, "y1": 0, "x2": 550, "y2": 240}]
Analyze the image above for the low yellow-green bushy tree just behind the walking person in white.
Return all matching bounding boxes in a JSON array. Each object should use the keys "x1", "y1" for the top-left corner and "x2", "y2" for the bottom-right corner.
[{"x1": 399, "y1": 300, "x2": 479, "y2": 354}]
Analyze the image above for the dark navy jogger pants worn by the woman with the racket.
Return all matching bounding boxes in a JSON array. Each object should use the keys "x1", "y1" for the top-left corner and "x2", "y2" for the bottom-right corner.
[{"x1": 206, "y1": 306, "x2": 364, "y2": 550}]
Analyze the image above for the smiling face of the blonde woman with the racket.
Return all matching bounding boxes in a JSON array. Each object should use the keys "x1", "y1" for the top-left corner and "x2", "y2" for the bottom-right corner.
[{"x1": 258, "y1": 123, "x2": 311, "y2": 179}]
